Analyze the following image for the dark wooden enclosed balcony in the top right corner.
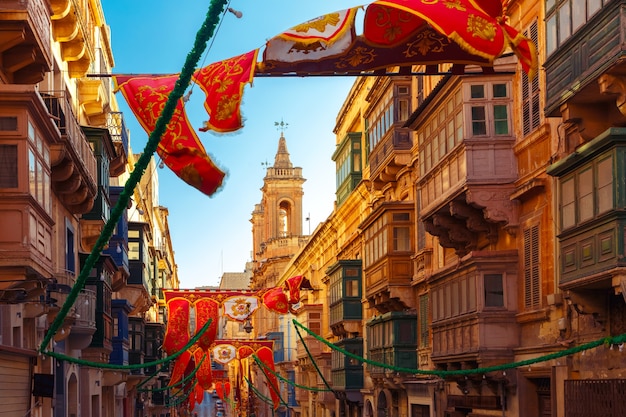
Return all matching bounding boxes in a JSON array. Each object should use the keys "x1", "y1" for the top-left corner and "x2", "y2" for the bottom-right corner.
[{"x1": 544, "y1": 1, "x2": 626, "y2": 141}]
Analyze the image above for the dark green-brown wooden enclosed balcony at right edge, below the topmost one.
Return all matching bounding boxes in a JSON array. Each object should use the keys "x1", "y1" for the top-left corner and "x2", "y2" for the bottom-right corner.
[{"x1": 547, "y1": 128, "x2": 626, "y2": 300}]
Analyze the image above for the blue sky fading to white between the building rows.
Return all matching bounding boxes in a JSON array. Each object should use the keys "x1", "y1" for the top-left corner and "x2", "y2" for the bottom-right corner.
[{"x1": 102, "y1": 0, "x2": 366, "y2": 288}]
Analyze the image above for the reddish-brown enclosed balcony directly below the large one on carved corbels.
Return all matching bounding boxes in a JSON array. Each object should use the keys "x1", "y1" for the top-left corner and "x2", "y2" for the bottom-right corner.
[{"x1": 431, "y1": 250, "x2": 519, "y2": 370}]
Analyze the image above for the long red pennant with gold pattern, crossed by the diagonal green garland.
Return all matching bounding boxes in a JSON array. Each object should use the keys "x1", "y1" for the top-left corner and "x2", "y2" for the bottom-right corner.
[{"x1": 113, "y1": 74, "x2": 224, "y2": 196}]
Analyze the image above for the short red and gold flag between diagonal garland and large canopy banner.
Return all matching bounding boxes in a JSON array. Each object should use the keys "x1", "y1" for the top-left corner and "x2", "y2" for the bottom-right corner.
[{"x1": 192, "y1": 49, "x2": 259, "y2": 132}]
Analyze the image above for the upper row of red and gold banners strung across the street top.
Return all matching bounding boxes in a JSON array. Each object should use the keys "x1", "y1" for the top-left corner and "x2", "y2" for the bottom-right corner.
[{"x1": 114, "y1": 0, "x2": 537, "y2": 196}]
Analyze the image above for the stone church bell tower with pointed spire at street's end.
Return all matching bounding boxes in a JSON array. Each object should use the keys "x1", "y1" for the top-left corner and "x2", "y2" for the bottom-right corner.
[{"x1": 250, "y1": 128, "x2": 308, "y2": 289}]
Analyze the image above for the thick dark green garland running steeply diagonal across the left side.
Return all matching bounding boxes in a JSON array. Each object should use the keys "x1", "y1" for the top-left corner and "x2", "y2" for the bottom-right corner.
[{"x1": 39, "y1": 0, "x2": 228, "y2": 354}]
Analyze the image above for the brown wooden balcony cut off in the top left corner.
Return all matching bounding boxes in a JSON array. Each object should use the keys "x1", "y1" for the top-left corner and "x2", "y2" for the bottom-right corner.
[{"x1": 0, "y1": 0, "x2": 52, "y2": 84}]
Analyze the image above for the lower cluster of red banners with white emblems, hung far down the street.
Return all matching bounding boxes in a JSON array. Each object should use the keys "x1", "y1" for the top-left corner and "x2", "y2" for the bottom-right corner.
[{"x1": 162, "y1": 282, "x2": 311, "y2": 407}]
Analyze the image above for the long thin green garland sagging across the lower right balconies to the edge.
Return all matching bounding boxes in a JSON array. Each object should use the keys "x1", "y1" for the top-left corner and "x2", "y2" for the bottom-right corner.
[{"x1": 293, "y1": 319, "x2": 626, "y2": 378}]
